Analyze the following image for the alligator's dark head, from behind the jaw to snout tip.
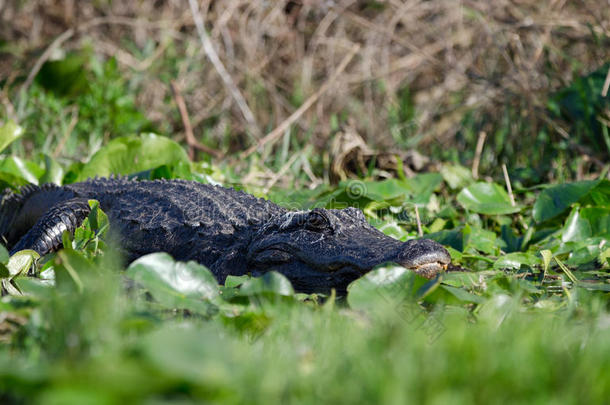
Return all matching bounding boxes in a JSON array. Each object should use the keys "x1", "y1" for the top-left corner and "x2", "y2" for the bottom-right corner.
[{"x1": 246, "y1": 208, "x2": 451, "y2": 293}]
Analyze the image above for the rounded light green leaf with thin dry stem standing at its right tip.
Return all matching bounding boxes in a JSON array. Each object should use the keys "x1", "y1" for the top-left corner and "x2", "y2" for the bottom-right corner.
[{"x1": 457, "y1": 182, "x2": 521, "y2": 215}]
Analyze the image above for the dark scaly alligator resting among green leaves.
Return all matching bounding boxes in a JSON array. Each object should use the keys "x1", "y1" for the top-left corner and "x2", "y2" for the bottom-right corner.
[{"x1": 0, "y1": 177, "x2": 450, "y2": 293}]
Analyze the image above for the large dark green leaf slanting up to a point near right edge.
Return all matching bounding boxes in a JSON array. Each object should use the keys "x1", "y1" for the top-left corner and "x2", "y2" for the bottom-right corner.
[{"x1": 532, "y1": 180, "x2": 599, "y2": 222}]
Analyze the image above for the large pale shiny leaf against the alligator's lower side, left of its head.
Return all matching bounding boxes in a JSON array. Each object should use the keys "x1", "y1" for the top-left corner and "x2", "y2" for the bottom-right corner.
[{"x1": 126, "y1": 253, "x2": 218, "y2": 314}]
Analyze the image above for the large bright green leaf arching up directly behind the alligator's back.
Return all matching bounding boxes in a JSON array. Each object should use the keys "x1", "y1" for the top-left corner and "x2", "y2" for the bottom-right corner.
[{"x1": 78, "y1": 134, "x2": 189, "y2": 180}]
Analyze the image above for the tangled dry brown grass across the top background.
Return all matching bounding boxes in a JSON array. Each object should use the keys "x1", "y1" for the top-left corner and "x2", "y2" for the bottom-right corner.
[{"x1": 0, "y1": 0, "x2": 610, "y2": 159}]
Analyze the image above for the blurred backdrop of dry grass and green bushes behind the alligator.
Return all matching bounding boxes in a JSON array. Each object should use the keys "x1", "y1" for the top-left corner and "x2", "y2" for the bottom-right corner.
[{"x1": 0, "y1": 0, "x2": 610, "y2": 182}]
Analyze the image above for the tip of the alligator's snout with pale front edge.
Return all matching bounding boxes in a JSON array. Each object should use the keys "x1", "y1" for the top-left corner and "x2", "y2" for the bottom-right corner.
[{"x1": 395, "y1": 239, "x2": 451, "y2": 278}]
